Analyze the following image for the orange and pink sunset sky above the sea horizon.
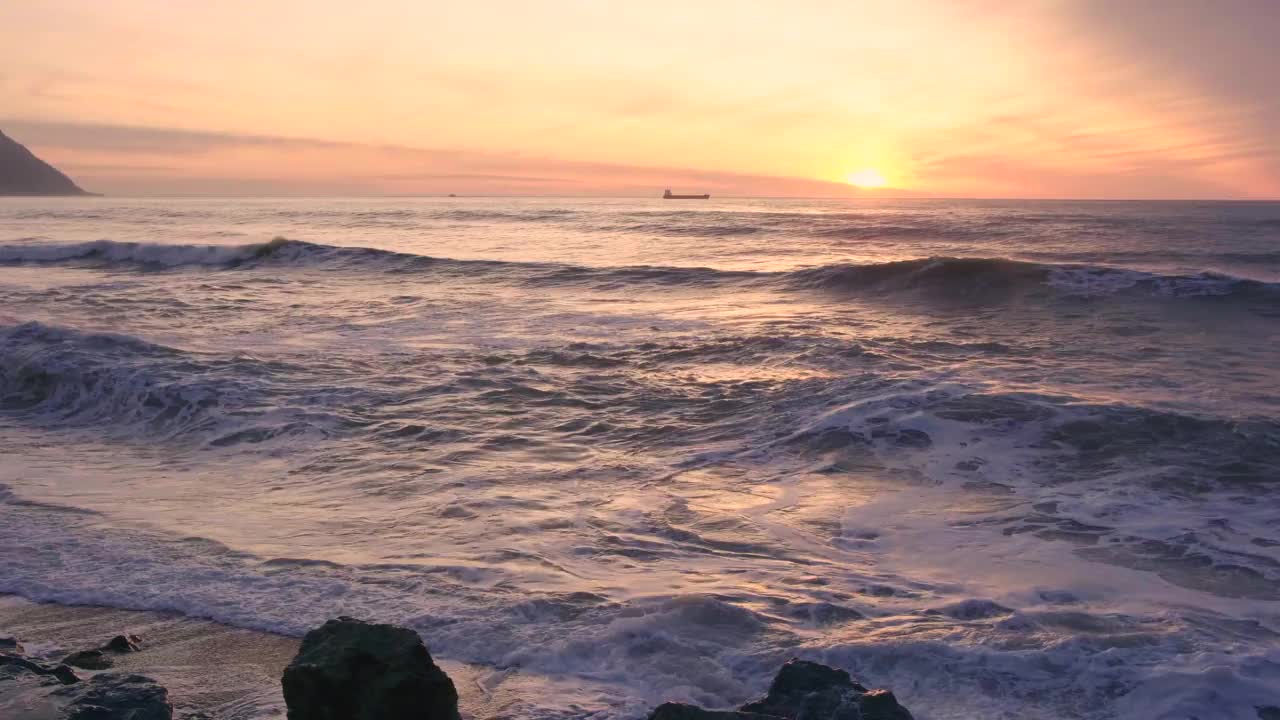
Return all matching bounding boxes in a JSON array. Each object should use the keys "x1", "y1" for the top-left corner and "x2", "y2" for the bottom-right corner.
[{"x1": 0, "y1": 0, "x2": 1280, "y2": 199}]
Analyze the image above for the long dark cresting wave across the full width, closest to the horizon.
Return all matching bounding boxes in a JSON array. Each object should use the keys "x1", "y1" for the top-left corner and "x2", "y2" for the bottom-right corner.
[{"x1": 0, "y1": 237, "x2": 1280, "y2": 300}]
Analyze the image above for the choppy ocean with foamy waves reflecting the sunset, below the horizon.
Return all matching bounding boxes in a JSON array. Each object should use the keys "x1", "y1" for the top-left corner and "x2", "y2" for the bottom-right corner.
[{"x1": 0, "y1": 199, "x2": 1280, "y2": 720}]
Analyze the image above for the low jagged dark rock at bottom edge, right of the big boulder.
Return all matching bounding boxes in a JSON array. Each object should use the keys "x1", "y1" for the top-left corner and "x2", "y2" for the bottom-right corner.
[{"x1": 649, "y1": 660, "x2": 911, "y2": 720}]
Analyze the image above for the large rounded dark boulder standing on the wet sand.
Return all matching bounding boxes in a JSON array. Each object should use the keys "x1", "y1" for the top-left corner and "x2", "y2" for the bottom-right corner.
[{"x1": 283, "y1": 609, "x2": 460, "y2": 720}]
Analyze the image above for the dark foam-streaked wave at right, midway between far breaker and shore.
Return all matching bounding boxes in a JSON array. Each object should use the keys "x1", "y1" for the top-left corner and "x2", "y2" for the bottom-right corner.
[{"x1": 776, "y1": 379, "x2": 1280, "y2": 471}]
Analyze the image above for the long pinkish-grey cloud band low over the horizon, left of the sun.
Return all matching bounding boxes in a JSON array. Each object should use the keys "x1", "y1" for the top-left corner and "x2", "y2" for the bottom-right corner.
[{"x1": 0, "y1": 118, "x2": 896, "y2": 196}]
